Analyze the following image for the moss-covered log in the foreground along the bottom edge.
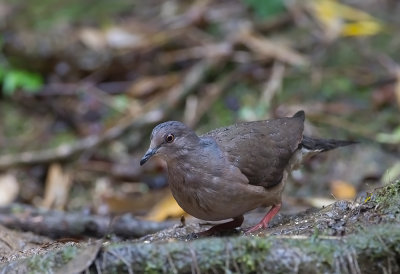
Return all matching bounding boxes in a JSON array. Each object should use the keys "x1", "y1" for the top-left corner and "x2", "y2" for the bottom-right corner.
[{"x1": 0, "y1": 224, "x2": 400, "y2": 273}]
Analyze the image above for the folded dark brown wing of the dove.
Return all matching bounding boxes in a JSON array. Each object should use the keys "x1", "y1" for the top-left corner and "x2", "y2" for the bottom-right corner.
[{"x1": 201, "y1": 111, "x2": 304, "y2": 187}]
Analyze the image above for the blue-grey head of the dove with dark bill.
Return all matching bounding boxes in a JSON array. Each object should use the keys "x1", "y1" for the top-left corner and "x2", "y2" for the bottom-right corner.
[{"x1": 140, "y1": 121, "x2": 199, "y2": 165}]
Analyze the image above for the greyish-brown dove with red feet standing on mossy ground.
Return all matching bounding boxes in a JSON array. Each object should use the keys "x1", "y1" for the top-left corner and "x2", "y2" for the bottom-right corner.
[{"x1": 140, "y1": 111, "x2": 354, "y2": 234}]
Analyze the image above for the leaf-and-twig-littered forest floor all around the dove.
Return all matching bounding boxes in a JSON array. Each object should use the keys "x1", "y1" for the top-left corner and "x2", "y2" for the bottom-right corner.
[{"x1": 0, "y1": 0, "x2": 400, "y2": 273}]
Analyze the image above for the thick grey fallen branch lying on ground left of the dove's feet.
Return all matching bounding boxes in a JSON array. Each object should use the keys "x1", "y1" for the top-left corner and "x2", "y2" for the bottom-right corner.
[{"x1": 0, "y1": 205, "x2": 174, "y2": 239}]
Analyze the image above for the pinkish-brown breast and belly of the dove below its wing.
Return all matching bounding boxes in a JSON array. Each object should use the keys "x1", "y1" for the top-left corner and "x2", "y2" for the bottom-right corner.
[{"x1": 168, "y1": 163, "x2": 268, "y2": 221}]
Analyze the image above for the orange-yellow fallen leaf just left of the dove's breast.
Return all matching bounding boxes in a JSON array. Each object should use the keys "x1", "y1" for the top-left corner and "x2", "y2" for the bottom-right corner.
[{"x1": 146, "y1": 189, "x2": 186, "y2": 221}]
